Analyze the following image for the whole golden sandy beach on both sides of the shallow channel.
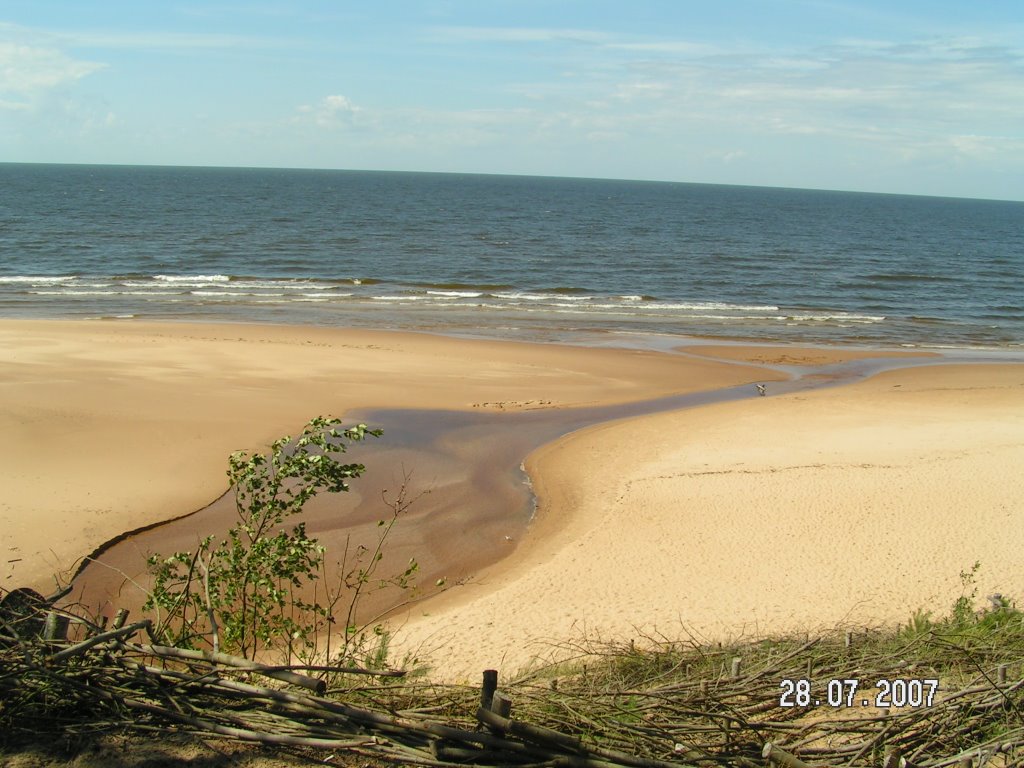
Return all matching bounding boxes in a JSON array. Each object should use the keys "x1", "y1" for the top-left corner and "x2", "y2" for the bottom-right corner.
[{"x1": 0, "y1": 321, "x2": 1024, "y2": 680}]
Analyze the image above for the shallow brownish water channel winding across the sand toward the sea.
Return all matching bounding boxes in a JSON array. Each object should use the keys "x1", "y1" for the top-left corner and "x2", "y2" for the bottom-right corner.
[{"x1": 74, "y1": 357, "x2": 948, "y2": 615}]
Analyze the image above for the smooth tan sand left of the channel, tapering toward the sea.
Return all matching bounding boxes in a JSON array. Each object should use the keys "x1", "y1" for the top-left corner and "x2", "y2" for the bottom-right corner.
[{"x1": 0, "y1": 321, "x2": 763, "y2": 592}]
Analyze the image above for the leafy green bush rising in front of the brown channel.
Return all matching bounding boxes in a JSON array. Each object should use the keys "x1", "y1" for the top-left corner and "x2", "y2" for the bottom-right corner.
[{"x1": 145, "y1": 417, "x2": 387, "y2": 658}]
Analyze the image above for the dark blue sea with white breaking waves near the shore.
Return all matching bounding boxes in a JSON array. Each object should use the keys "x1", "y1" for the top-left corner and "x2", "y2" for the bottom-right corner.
[{"x1": 0, "y1": 164, "x2": 1024, "y2": 349}]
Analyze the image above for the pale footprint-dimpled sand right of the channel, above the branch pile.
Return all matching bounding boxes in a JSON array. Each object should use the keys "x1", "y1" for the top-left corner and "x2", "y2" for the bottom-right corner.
[{"x1": 391, "y1": 360, "x2": 1024, "y2": 681}]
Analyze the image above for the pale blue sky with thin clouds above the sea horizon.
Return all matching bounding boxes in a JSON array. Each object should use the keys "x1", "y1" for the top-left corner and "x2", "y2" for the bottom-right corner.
[{"x1": 0, "y1": 0, "x2": 1024, "y2": 200}]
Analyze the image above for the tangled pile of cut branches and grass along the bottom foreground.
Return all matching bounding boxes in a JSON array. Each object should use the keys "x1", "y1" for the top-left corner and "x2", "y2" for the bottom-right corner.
[{"x1": 0, "y1": 589, "x2": 1024, "y2": 768}]
